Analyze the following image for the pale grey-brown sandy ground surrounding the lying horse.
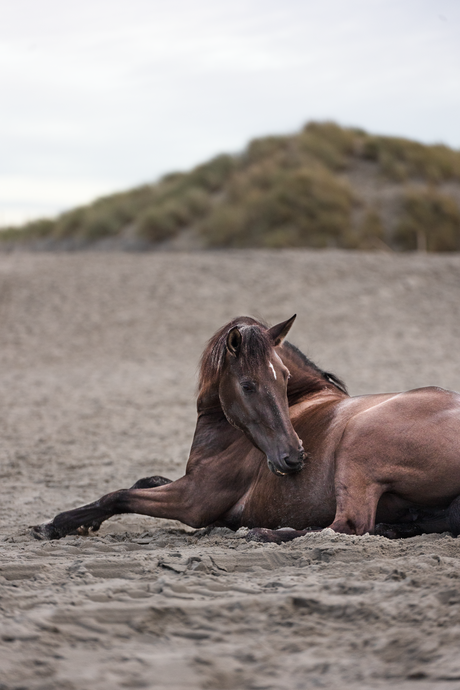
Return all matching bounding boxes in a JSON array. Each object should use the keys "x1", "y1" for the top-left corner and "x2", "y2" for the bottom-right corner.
[{"x1": 0, "y1": 251, "x2": 460, "y2": 690}]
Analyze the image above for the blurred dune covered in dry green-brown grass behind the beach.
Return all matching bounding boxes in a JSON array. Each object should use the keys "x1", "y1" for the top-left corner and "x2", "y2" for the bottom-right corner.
[{"x1": 1, "y1": 122, "x2": 460, "y2": 251}]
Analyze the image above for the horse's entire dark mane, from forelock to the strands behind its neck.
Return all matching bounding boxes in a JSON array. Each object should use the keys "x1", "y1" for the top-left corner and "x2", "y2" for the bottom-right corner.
[{"x1": 198, "y1": 316, "x2": 348, "y2": 398}]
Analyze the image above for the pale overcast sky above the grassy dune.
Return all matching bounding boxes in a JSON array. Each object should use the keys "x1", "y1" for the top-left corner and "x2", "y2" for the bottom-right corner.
[{"x1": 0, "y1": 0, "x2": 460, "y2": 226}]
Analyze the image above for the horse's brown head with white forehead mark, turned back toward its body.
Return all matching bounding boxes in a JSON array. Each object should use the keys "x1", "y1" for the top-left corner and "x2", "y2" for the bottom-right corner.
[{"x1": 219, "y1": 316, "x2": 305, "y2": 476}]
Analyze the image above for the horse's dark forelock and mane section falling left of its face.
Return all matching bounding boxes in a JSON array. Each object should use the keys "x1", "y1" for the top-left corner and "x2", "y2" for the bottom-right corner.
[{"x1": 198, "y1": 316, "x2": 273, "y2": 397}]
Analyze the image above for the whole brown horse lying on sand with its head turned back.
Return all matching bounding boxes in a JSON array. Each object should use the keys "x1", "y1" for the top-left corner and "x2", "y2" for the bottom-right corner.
[{"x1": 33, "y1": 316, "x2": 460, "y2": 542}]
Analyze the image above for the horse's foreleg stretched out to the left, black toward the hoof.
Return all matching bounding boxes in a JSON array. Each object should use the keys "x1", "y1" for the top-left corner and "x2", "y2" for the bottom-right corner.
[{"x1": 32, "y1": 476, "x2": 203, "y2": 539}]
